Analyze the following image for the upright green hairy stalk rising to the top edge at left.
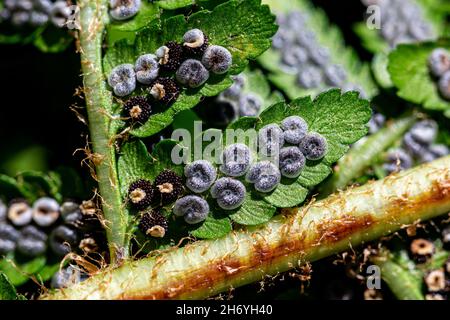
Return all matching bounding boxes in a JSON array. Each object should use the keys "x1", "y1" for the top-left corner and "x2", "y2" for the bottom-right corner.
[{"x1": 78, "y1": 0, "x2": 128, "y2": 263}]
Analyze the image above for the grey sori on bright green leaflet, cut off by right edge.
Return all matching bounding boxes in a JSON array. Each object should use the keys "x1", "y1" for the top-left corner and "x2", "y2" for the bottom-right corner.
[{"x1": 428, "y1": 48, "x2": 450, "y2": 100}]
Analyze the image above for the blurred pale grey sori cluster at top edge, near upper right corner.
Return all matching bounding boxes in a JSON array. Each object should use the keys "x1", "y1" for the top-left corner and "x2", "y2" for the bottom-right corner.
[{"x1": 362, "y1": 0, "x2": 436, "y2": 48}]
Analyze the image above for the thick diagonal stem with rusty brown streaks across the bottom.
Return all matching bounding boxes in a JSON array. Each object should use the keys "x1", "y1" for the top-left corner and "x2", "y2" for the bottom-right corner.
[{"x1": 43, "y1": 156, "x2": 450, "y2": 299}]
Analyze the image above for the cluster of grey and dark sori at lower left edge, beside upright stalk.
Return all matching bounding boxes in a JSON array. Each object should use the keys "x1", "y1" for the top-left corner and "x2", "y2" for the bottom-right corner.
[{"x1": 0, "y1": 197, "x2": 105, "y2": 286}]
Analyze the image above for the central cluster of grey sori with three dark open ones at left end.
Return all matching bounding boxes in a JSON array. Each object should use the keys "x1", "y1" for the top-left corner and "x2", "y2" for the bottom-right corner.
[{"x1": 128, "y1": 116, "x2": 328, "y2": 237}]
